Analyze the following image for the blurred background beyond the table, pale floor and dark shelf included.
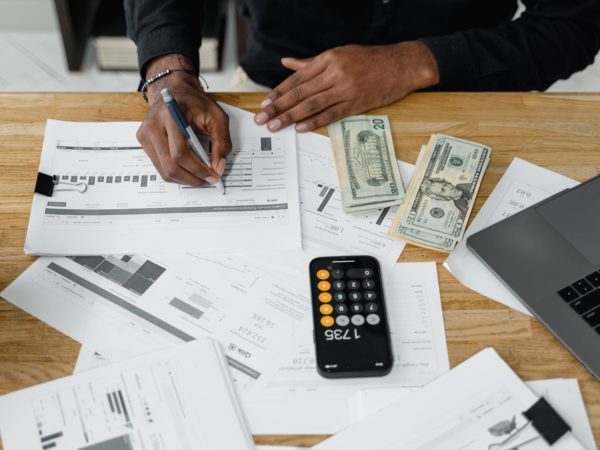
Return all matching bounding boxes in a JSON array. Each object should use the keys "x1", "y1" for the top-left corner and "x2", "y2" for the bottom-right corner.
[{"x1": 0, "y1": 0, "x2": 600, "y2": 92}]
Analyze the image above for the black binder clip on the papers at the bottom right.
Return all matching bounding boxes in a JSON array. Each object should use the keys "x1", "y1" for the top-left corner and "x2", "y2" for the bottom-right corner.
[{"x1": 488, "y1": 397, "x2": 571, "y2": 450}]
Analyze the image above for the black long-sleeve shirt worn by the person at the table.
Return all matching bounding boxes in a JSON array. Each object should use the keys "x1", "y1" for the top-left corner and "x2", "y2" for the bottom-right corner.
[{"x1": 125, "y1": 0, "x2": 600, "y2": 91}]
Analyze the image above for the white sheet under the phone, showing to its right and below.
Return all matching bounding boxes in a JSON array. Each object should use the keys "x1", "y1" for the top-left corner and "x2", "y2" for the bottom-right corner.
[{"x1": 243, "y1": 263, "x2": 449, "y2": 434}]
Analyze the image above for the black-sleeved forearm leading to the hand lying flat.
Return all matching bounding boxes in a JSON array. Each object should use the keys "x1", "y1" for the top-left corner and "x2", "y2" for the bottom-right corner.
[{"x1": 421, "y1": 0, "x2": 600, "y2": 91}]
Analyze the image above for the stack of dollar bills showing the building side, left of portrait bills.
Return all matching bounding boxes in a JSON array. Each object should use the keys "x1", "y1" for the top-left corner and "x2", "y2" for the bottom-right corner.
[{"x1": 329, "y1": 115, "x2": 405, "y2": 213}]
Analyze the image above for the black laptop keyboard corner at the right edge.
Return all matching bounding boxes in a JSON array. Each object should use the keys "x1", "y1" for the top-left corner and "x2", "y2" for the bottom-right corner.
[{"x1": 558, "y1": 271, "x2": 600, "y2": 334}]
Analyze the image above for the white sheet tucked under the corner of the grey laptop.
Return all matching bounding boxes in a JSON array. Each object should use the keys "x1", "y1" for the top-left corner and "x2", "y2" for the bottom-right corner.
[{"x1": 444, "y1": 158, "x2": 577, "y2": 315}]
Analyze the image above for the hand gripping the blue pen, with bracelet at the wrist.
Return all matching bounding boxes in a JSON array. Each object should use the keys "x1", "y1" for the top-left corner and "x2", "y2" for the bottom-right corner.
[{"x1": 137, "y1": 55, "x2": 231, "y2": 186}]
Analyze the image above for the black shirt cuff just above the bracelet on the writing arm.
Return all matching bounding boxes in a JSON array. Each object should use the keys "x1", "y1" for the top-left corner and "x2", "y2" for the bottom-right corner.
[{"x1": 137, "y1": 26, "x2": 202, "y2": 79}]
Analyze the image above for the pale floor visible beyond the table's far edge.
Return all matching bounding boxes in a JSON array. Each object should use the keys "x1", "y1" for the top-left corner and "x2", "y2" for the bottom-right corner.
[{"x1": 0, "y1": 24, "x2": 600, "y2": 92}]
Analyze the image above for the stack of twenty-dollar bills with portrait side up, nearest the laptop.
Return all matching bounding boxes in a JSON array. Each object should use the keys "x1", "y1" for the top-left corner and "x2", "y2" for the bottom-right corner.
[{"x1": 388, "y1": 134, "x2": 492, "y2": 252}]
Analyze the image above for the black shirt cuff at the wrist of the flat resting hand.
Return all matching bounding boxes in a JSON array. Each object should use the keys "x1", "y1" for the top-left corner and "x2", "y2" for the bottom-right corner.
[{"x1": 419, "y1": 33, "x2": 476, "y2": 91}]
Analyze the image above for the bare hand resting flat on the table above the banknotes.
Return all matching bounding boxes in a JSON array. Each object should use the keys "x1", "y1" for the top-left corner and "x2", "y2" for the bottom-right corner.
[{"x1": 254, "y1": 41, "x2": 439, "y2": 132}]
